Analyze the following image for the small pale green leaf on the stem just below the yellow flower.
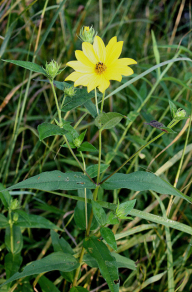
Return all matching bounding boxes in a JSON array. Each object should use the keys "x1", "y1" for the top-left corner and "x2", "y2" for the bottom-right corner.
[{"x1": 95, "y1": 112, "x2": 124, "y2": 130}]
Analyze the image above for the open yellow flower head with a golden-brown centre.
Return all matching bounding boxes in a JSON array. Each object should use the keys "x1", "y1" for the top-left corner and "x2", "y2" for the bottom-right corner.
[{"x1": 65, "y1": 36, "x2": 137, "y2": 92}]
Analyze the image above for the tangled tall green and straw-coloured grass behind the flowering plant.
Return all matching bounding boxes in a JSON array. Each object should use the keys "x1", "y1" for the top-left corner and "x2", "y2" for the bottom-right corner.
[{"x1": 0, "y1": 0, "x2": 192, "y2": 292}]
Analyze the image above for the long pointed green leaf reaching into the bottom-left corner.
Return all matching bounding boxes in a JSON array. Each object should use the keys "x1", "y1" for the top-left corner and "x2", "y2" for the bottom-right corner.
[{"x1": 0, "y1": 252, "x2": 79, "y2": 287}]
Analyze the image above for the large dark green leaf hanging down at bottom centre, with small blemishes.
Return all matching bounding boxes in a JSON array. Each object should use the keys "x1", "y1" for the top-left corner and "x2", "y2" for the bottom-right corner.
[{"x1": 83, "y1": 236, "x2": 119, "y2": 292}]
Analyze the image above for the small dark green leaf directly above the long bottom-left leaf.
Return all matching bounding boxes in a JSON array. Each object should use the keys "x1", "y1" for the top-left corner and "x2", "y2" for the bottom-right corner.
[{"x1": 51, "y1": 230, "x2": 74, "y2": 255}]
